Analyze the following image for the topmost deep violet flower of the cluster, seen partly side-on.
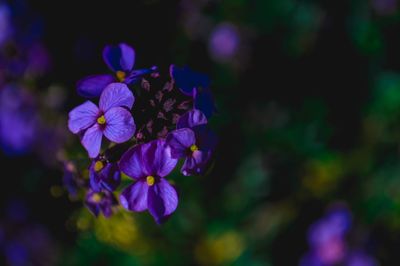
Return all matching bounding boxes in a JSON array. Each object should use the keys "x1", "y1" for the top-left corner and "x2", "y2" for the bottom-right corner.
[{"x1": 77, "y1": 43, "x2": 157, "y2": 98}]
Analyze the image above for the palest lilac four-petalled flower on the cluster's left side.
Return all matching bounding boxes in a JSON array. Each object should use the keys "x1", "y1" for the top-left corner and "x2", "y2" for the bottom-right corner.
[{"x1": 68, "y1": 83, "x2": 136, "y2": 158}]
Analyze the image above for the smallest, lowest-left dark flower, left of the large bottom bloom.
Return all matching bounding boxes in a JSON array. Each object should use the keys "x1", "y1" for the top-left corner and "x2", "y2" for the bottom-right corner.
[{"x1": 85, "y1": 190, "x2": 118, "y2": 217}]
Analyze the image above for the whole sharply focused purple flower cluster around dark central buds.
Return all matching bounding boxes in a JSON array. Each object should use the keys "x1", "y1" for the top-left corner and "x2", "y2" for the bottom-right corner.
[{"x1": 65, "y1": 43, "x2": 216, "y2": 223}]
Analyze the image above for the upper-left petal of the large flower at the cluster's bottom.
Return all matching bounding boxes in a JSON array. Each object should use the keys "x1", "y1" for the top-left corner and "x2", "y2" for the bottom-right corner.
[{"x1": 119, "y1": 144, "x2": 151, "y2": 179}]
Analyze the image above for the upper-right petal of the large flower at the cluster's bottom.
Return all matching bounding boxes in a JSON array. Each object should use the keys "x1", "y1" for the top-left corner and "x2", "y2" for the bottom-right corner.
[{"x1": 143, "y1": 139, "x2": 178, "y2": 177}]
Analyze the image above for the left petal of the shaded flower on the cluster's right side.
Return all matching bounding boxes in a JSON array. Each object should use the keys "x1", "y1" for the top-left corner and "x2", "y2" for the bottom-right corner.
[{"x1": 166, "y1": 128, "x2": 196, "y2": 159}]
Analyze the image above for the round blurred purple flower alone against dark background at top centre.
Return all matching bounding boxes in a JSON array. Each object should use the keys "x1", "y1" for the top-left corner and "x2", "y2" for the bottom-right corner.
[{"x1": 208, "y1": 23, "x2": 240, "y2": 62}]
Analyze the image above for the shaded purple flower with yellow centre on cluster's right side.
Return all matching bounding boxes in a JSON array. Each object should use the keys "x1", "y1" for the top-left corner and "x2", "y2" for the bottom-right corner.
[{"x1": 166, "y1": 110, "x2": 216, "y2": 176}]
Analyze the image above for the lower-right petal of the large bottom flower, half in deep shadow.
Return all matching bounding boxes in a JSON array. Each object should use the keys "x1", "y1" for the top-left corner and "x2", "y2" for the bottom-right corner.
[{"x1": 147, "y1": 178, "x2": 178, "y2": 223}]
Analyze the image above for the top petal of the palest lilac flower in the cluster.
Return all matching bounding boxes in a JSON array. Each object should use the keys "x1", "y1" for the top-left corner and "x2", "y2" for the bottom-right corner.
[{"x1": 99, "y1": 83, "x2": 135, "y2": 112}]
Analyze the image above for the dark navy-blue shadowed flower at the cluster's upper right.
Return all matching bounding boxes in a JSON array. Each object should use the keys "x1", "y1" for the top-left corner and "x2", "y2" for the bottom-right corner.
[{"x1": 170, "y1": 65, "x2": 216, "y2": 118}]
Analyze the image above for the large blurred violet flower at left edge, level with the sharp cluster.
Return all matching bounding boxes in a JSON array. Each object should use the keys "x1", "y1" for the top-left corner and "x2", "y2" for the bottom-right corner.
[{"x1": 0, "y1": 85, "x2": 39, "y2": 155}]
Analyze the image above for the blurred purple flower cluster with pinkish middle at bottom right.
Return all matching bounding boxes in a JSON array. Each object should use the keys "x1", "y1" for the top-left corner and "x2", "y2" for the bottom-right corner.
[{"x1": 300, "y1": 206, "x2": 377, "y2": 266}]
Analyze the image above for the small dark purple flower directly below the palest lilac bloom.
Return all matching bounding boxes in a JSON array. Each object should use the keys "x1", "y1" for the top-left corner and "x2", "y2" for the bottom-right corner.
[{"x1": 89, "y1": 159, "x2": 121, "y2": 192}]
